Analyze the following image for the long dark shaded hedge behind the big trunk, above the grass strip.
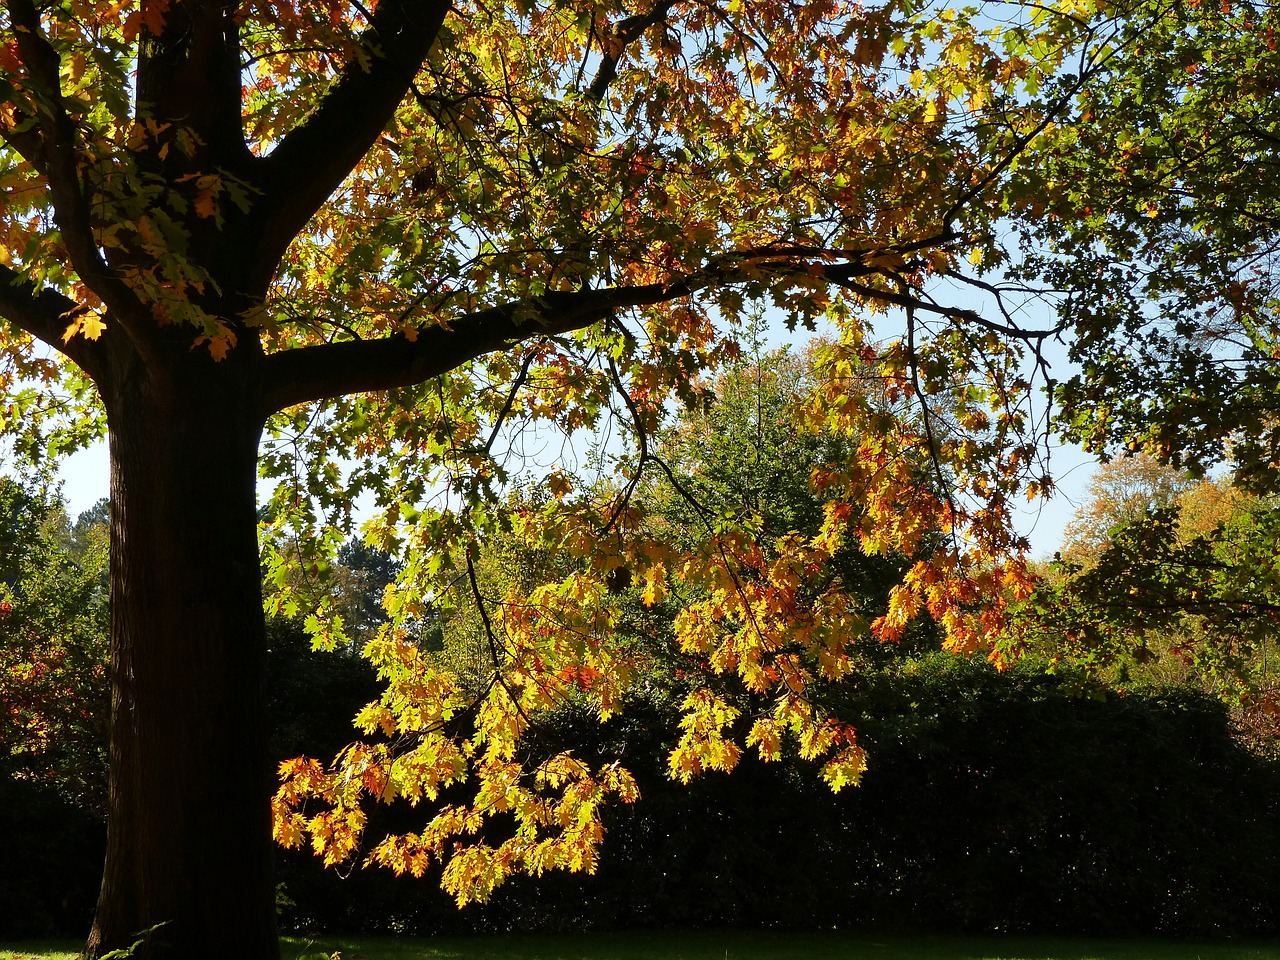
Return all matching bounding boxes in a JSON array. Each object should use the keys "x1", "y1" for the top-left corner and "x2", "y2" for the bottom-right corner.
[{"x1": 0, "y1": 637, "x2": 1280, "y2": 937}]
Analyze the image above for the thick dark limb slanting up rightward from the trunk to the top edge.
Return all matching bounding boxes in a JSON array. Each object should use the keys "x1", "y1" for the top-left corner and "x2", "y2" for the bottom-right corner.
[{"x1": 248, "y1": 0, "x2": 449, "y2": 289}]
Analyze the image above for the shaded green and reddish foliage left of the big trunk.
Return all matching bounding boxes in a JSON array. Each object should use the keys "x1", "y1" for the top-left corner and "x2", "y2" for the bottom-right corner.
[{"x1": 0, "y1": 477, "x2": 110, "y2": 936}]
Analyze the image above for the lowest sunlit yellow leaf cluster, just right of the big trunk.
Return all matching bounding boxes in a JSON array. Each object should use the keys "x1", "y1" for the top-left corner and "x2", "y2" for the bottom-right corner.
[{"x1": 273, "y1": 640, "x2": 637, "y2": 905}]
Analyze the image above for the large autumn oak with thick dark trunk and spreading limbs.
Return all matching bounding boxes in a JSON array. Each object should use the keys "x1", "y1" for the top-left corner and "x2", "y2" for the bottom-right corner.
[{"x1": 0, "y1": 0, "x2": 1097, "y2": 960}]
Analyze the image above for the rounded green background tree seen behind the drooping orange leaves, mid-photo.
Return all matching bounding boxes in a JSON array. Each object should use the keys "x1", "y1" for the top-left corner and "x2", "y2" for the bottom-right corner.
[{"x1": 641, "y1": 340, "x2": 945, "y2": 665}]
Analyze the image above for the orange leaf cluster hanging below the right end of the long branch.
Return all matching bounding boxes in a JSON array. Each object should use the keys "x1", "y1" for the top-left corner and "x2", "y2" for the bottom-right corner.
[{"x1": 809, "y1": 338, "x2": 1034, "y2": 662}]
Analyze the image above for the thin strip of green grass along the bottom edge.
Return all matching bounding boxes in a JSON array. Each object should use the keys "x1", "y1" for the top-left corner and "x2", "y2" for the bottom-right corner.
[{"x1": 0, "y1": 931, "x2": 1280, "y2": 960}]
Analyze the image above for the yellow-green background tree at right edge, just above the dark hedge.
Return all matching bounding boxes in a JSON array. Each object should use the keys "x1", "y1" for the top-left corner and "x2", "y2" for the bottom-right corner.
[{"x1": 1011, "y1": 465, "x2": 1280, "y2": 716}]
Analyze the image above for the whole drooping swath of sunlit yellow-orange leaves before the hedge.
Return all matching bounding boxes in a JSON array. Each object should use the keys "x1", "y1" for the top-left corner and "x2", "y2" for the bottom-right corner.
[{"x1": 276, "y1": 325, "x2": 1030, "y2": 902}]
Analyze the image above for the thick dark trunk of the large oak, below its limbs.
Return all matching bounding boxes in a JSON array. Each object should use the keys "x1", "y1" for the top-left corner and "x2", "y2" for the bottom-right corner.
[{"x1": 88, "y1": 351, "x2": 279, "y2": 960}]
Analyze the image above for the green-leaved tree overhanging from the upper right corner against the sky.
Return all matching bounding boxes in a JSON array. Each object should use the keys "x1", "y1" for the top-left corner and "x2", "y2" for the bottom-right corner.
[{"x1": 1016, "y1": 3, "x2": 1280, "y2": 481}]
